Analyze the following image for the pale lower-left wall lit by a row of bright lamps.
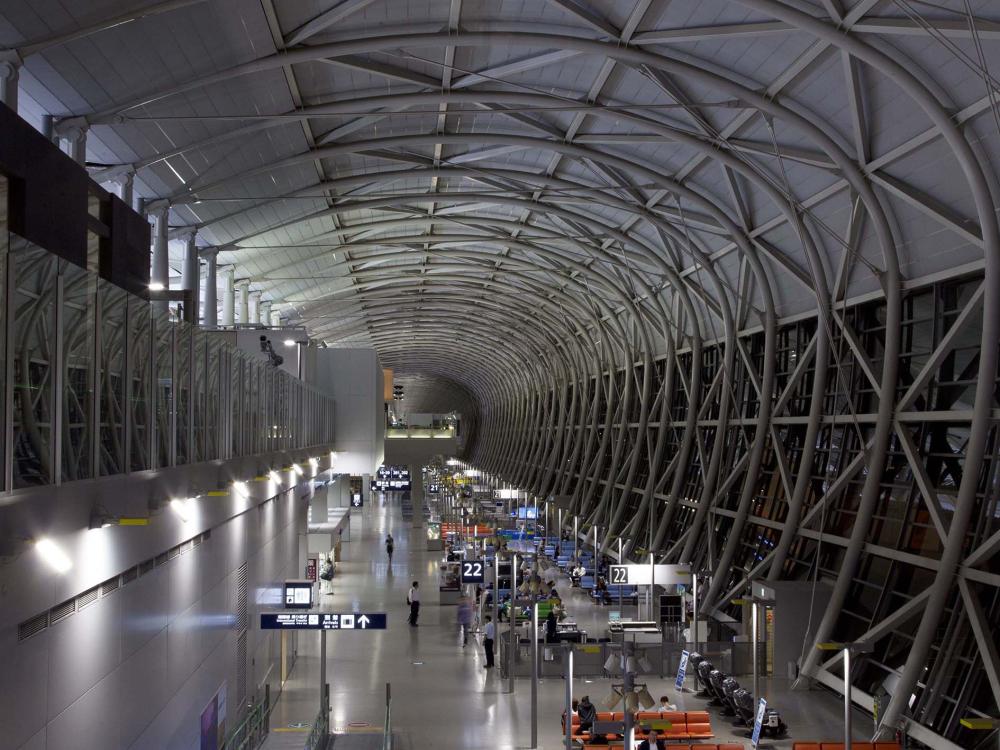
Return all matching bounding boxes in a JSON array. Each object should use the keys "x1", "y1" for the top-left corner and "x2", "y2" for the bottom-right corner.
[{"x1": 0, "y1": 490, "x2": 308, "y2": 750}]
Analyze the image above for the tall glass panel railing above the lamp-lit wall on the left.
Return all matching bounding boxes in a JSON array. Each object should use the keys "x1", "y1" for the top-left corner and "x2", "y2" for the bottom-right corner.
[{"x1": 0, "y1": 235, "x2": 334, "y2": 491}]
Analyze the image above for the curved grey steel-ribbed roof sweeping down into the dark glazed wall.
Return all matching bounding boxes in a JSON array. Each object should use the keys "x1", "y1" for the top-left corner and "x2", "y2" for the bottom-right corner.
[{"x1": 3, "y1": 0, "x2": 1000, "y2": 747}]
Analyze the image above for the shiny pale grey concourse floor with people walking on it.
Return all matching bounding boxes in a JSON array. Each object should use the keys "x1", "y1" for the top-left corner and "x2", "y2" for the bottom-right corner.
[{"x1": 266, "y1": 497, "x2": 872, "y2": 750}]
